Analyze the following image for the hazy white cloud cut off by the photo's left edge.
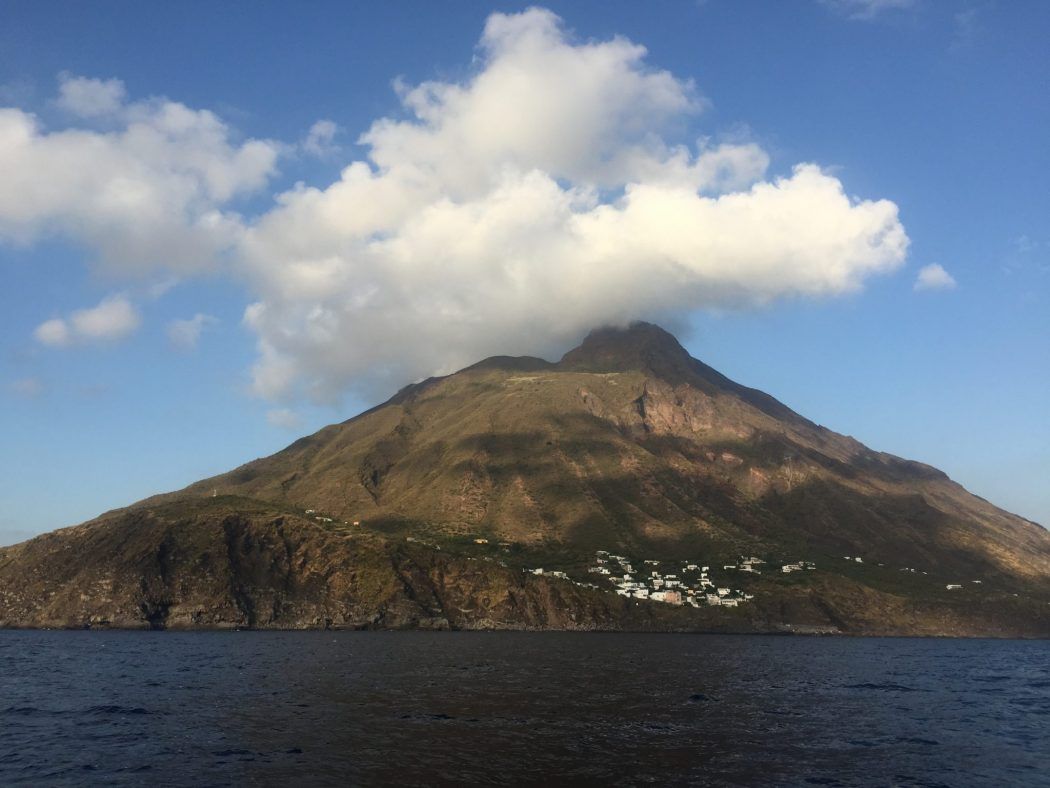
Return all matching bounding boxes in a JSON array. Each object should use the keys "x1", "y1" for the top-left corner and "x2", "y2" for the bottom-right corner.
[{"x1": 0, "y1": 76, "x2": 280, "y2": 273}]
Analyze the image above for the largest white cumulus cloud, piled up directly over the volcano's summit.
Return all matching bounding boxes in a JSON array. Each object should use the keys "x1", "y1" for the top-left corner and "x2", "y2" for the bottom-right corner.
[{"x1": 239, "y1": 8, "x2": 907, "y2": 400}]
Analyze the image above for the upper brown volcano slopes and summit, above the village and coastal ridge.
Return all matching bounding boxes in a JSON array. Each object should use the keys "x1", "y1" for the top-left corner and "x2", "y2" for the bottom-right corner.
[{"x1": 159, "y1": 325, "x2": 1050, "y2": 581}]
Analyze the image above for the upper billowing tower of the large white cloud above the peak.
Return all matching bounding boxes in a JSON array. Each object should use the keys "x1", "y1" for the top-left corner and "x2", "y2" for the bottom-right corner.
[{"x1": 360, "y1": 8, "x2": 704, "y2": 199}]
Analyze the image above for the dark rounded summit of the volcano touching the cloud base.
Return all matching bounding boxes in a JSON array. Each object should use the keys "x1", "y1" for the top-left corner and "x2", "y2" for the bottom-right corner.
[{"x1": 559, "y1": 322, "x2": 695, "y2": 377}]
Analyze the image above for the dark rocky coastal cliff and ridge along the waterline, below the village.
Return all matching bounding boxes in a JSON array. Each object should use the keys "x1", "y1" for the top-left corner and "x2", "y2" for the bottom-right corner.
[{"x1": 0, "y1": 496, "x2": 1050, "y2": 637}]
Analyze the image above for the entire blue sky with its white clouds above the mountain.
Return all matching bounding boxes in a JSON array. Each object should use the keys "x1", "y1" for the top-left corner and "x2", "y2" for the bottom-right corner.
[{"x1": 0, "y1": 0, "x2": 1050, "y2": 543}]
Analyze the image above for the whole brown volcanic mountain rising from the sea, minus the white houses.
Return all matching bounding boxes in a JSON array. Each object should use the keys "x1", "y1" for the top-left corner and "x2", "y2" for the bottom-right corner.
[{"x1": 0, "y1": 324, "x2": 1050, "y2": 636}]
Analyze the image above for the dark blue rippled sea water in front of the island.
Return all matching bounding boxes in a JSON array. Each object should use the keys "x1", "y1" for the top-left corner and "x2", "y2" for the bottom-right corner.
[{"x1": 0, "y1": 631, "x2": 1050, "y2": 786}]
